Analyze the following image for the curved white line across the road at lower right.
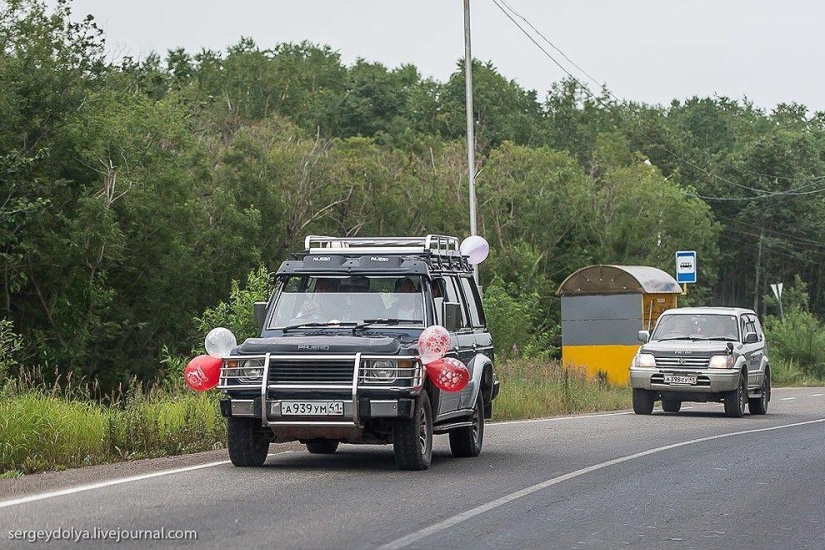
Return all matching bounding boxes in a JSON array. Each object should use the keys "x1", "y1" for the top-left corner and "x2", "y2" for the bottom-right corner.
[{"x1": 380, "y1": 418, "x2": 825, "y2": 550}]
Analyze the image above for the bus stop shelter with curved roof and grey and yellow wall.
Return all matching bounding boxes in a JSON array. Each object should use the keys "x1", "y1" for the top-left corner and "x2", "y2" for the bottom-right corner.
[{"x1": 556, "y1": 265, "x2": 682, "y2": 385}]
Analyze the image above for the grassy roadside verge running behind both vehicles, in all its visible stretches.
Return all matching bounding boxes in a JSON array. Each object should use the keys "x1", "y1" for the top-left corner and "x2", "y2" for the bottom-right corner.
[{"x1": 0, "y1": 358, "x2": 822, "y2": 478}]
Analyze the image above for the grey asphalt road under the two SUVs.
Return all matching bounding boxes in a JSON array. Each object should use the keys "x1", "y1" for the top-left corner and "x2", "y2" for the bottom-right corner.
[{"x1": 0, "y1": 388, "x2": 825, "y2": 549}]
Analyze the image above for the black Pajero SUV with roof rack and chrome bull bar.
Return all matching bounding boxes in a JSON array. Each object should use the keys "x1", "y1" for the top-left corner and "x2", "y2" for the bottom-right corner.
[{"x1": 218, "y1": 235, "x2": 499, "y2": 470}]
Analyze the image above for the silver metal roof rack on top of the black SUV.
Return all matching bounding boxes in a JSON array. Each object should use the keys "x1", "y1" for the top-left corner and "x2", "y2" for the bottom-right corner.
[{"x1": 304, "y1": 235, "x2": 461, "y2": 259}]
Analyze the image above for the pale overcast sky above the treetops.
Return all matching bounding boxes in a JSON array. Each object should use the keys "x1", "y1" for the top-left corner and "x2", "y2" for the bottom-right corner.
[{"x1": 58, "y1": 0, "x2": 825, "y2": 111}]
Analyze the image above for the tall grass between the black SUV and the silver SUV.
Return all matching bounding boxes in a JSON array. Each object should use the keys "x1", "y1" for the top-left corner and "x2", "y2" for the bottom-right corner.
[{"x1": 493, "y1": 359, "x2": 631, "y2": 420}]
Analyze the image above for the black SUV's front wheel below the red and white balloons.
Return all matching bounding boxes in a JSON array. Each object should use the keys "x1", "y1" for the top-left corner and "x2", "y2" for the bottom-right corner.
[{"x1": 392, "y1": 392, "x2": 433, "y2": 470}]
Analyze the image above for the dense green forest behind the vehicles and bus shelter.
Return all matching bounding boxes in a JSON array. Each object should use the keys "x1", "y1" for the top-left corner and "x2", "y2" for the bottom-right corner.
[{"x1": 0, "y1": 0, "x2": 825, "y2": 393}]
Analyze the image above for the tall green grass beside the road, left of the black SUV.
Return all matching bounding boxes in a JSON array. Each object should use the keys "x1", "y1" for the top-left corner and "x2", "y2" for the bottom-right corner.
[{"x1": 0, "y1": 374, "x2": 225, "y2": 475}]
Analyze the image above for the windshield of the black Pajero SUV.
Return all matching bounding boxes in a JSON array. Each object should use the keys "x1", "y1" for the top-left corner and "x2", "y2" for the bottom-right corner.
[{"x1": 268, "y1": 275, "x2": 424, "y2": 329}]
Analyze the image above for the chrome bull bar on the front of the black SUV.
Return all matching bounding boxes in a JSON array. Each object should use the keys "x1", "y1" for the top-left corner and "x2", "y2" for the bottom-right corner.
[{"x1": 217, "y1": 352, "x2": 424, "y2": 428}]
